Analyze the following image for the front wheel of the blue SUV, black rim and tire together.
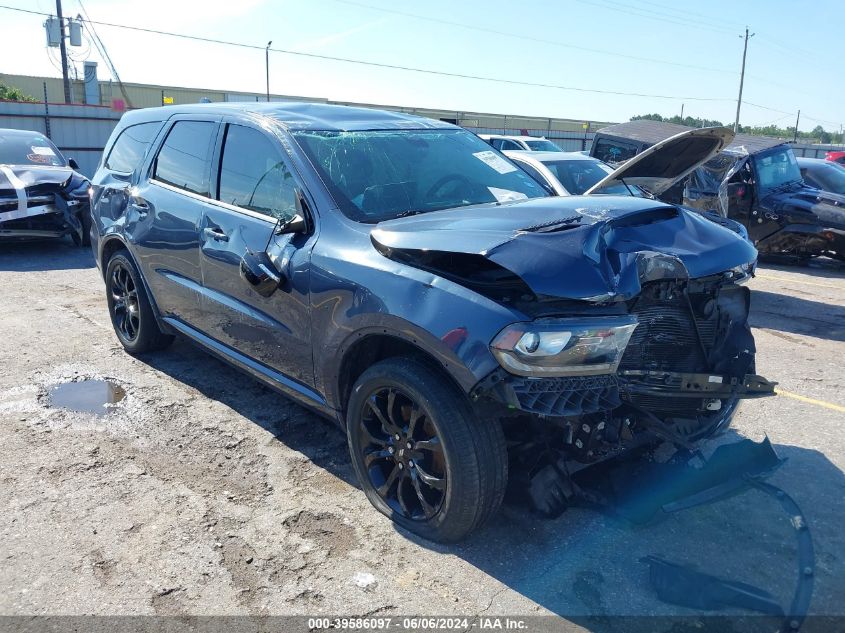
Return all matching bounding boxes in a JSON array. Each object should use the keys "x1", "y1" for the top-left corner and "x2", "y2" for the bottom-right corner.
[{"x1": 347, "y1": 357, "x2": 508, "y2": 542}]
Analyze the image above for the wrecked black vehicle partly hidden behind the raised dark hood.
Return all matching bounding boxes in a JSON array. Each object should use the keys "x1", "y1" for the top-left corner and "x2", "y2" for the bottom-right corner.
[{"x1": 590, "y1": 121, "x2": 845, "y2": 260}]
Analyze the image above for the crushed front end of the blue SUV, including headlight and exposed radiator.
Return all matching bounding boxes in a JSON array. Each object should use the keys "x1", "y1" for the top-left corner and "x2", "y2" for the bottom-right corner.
[{"x1": 473, "y1": 260, "x2": 774, "y2": 515}]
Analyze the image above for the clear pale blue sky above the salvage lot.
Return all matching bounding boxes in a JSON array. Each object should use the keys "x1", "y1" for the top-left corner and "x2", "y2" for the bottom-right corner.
[{"x1": 0, "y1": 0, "x2": 845, "y2": 131}]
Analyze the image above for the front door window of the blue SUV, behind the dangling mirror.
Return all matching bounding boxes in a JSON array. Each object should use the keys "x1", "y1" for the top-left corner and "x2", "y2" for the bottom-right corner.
[{"x1": 220, "y1": 125, "x2": 296, "y2": 219}]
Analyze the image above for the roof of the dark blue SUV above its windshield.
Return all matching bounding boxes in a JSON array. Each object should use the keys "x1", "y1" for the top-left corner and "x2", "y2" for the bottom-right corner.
[{"x1": 115, "y1": 101, "x2": 458, "y2": 131}]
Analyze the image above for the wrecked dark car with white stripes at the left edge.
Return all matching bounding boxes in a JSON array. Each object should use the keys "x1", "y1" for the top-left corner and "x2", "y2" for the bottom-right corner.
[{"x1": 0, "y1": 129, "x2": 91, "y2": 246}]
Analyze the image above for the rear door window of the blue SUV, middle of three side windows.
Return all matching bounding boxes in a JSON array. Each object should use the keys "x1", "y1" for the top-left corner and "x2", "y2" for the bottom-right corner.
[{"x1": 155, "y1": 121, "x2": 217, "y2": 196}]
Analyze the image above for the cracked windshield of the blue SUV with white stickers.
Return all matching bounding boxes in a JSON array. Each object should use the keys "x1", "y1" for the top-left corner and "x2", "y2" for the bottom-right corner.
[{"x1": 294, "y1": 129, "x2": 547, "y2": 223}]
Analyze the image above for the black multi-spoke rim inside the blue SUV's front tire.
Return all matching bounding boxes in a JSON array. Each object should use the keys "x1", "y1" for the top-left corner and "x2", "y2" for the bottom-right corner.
[{"x1": 358, "y1": 387, "x2": 447, "y2": 521}]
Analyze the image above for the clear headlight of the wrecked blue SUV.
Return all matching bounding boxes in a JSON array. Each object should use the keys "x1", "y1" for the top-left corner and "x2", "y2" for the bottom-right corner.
[{"x1": 490, "y1": 316, "x2": 637, "y2": 376}]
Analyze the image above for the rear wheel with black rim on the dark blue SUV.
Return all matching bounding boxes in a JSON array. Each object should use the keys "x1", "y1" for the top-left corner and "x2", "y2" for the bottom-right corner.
[{"x1": 106, "y1": 250, "x2": 173, "y2": 354}]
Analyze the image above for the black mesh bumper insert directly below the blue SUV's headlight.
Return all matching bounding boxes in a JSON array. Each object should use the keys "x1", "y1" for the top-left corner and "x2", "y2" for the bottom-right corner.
[{"x1": 498, "y1": 376, "x2": 621, "y2": 416}]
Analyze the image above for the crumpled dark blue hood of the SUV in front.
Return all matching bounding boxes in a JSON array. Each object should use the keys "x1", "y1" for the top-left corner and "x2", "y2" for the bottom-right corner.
[{"x1": 371, "y1": 196, "x2": 757, "y2": 301}]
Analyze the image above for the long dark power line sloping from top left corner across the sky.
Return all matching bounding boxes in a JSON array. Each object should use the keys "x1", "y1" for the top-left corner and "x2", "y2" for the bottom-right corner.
[{"x1": 0, "y1": 5, "x2": 733, "y2": 102}]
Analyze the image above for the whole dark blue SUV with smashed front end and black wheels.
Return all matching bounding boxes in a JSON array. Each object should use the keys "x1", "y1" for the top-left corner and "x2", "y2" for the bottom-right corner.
[{"x1": 92, "y1": 103, "x2": 773, "y2": 541}]
